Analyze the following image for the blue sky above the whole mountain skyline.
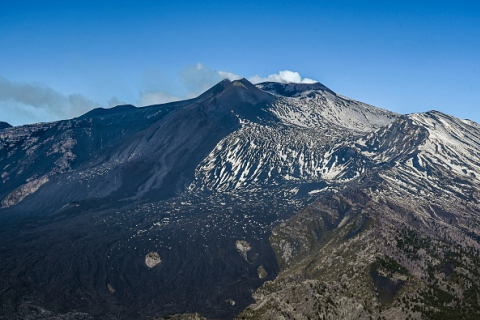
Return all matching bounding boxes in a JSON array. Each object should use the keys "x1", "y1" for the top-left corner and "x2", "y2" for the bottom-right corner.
[{"x1": 0, "y1": 0, "x2": 480, "y2": 125}]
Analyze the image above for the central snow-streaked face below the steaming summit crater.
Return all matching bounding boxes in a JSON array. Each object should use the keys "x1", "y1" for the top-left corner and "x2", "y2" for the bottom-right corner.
[{"x1": 190, "y1": 83, "x2": 397, "y2": 191}]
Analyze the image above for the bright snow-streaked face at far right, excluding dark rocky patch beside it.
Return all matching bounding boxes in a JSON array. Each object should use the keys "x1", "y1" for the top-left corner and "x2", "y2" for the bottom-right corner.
[{"x1": 382, "y1": 111, "x2": 480, "y2": 199}]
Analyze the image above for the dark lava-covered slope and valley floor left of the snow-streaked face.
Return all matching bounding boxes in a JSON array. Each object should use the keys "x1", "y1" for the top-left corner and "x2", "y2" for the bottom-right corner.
[{"x1": 0, "y1": 80, "x2": 284, "y2": 318}]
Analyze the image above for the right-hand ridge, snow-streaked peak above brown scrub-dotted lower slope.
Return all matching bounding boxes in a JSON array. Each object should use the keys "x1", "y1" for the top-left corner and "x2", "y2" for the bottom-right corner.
[{"x1": 241, "y1": 111, "x2": 480, "y2": 319}]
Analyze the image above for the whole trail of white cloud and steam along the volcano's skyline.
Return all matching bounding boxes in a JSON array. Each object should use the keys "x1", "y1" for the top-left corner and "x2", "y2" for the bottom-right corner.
[{"x1": 0, "y1": 63, "x2": 316, "y2": 125}]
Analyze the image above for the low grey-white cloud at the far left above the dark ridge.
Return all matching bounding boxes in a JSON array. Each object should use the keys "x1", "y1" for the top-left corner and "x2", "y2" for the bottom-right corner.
[{"x1": 0, "y1": 77, "x2": 100, "y2": 125}]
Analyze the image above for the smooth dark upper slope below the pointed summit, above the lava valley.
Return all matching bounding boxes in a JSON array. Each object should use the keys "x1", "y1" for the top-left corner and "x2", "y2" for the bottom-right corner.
[{"x1": 0, "y1": 80, "x2": 273, "y2": 213}]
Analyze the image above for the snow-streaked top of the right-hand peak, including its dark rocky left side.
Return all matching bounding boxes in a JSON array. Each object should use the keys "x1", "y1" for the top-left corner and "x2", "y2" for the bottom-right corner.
[{"x1": 326, "y1": 111, "x2": 480, "y2": 198}]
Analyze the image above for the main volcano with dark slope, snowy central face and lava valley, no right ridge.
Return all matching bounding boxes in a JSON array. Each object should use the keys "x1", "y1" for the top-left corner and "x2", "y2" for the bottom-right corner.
[{"x1": 0, "y1": 79, "x2": 397, "y2": 318}]
